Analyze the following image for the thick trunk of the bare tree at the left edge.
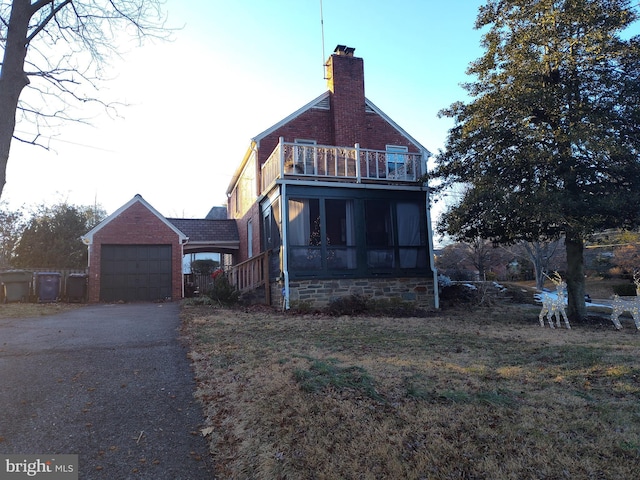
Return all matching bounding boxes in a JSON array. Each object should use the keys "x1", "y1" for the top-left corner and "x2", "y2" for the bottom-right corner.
[{"x1": 0, "y1": 0, "x2": 32, "y2": 198}]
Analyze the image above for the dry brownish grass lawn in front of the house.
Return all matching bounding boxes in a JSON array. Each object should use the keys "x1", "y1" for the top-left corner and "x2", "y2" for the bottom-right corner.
[{"x1": 182, "y1": 305, "x2": 640, "y2": 480}]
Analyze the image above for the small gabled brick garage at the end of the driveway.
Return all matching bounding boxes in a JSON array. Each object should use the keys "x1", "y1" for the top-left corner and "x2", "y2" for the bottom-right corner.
[{"x1": 82, "y1": 195, "x2": 188, "y2": 302}]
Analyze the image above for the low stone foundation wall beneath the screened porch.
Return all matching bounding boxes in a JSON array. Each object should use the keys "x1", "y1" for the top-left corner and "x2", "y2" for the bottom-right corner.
[{"x1": 272, "y1": 278, "x2": 435, "y2": 308}]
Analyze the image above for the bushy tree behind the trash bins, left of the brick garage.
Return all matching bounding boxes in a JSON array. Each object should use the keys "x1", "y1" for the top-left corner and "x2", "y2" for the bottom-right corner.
[{"x1": 13, "y1": 202, "x2": 106, "y2": 268}]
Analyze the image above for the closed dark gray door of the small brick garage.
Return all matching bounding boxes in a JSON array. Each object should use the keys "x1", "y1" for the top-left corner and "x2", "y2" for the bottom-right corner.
[{"x1": 100, "y1": 245, "x2": 171, "y2": 302}]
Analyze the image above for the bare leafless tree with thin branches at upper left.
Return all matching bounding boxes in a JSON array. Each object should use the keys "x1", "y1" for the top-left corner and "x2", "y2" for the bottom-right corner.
[{"x1": 0, "y1": 0, "x2": 164, "y2": 196}]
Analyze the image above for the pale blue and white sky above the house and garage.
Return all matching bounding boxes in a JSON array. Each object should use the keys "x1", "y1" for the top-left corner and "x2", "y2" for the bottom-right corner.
[{"x1": 2, "y1": 0, "x2": 483, "y2": 218}]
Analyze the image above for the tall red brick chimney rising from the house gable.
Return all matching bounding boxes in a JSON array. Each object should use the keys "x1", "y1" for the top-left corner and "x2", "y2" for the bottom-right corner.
[{"x1": 327, "y1": 45, "x2": 365, "y2": 146}]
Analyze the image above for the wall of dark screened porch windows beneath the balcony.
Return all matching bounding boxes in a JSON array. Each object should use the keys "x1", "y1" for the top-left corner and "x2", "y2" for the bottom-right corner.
[{"x1": 287, "y1": 189, "x2": 428, "y2": 277}]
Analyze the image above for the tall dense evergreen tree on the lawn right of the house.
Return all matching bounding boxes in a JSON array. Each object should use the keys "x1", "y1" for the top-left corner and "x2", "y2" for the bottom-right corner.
[{"x1": 435, "y1": 0, "x2": 640, "y2": 320}]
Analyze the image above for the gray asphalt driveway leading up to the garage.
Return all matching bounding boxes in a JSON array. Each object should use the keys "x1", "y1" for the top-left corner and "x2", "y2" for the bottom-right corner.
[{"x1": 0, "y1": 303, "x2": 213, "y2": 480}]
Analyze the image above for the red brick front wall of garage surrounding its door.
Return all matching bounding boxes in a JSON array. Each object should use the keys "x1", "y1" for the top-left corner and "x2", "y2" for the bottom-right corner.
[{"x1": 89, "y1": 203, "x2": 182, "y2": 302}]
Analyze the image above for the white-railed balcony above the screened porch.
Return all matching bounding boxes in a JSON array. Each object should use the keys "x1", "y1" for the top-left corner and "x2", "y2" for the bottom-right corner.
[{"x1": 261, "y1": 138, "x2": 424, "y2": 192}]
